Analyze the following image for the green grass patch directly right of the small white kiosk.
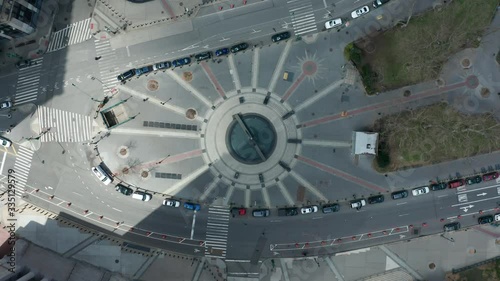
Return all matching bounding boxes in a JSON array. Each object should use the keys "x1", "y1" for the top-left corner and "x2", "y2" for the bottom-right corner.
[{"x1": 373, "y1": 103, "x2": 500, "y2": 172}]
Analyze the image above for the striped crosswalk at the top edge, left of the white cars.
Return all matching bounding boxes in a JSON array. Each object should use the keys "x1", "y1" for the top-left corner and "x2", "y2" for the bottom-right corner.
[{"x1": 286, "y1": 0, "x2": 318, "y2": 35}]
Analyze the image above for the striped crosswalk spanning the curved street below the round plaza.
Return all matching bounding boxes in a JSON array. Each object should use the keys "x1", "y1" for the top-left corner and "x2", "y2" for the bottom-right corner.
[{"x1": 205, "y1": 206, "x2": 229, "y2": 258}]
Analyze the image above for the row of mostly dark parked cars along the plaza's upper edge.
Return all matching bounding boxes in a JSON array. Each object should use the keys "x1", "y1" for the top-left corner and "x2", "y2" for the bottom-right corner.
[{"x1": 117, "y1": 31, "x2": 291, "y2": 82}]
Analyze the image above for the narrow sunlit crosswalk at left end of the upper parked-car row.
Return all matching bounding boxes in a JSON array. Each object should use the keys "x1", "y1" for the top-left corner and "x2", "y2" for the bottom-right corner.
[{"x1": 94, "y1": 40, "x2": 120, "y2": 95}]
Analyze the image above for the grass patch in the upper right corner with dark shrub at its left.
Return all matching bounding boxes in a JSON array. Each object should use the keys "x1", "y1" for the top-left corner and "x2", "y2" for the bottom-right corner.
[{"x1": 354, "y1": 0, "x2": 499, "y2": 94}]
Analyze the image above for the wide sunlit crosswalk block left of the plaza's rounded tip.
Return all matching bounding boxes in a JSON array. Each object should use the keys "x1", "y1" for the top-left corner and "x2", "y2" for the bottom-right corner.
[{"x1": 38, "y1": 106, "x2": 92, "y2": 142}]
